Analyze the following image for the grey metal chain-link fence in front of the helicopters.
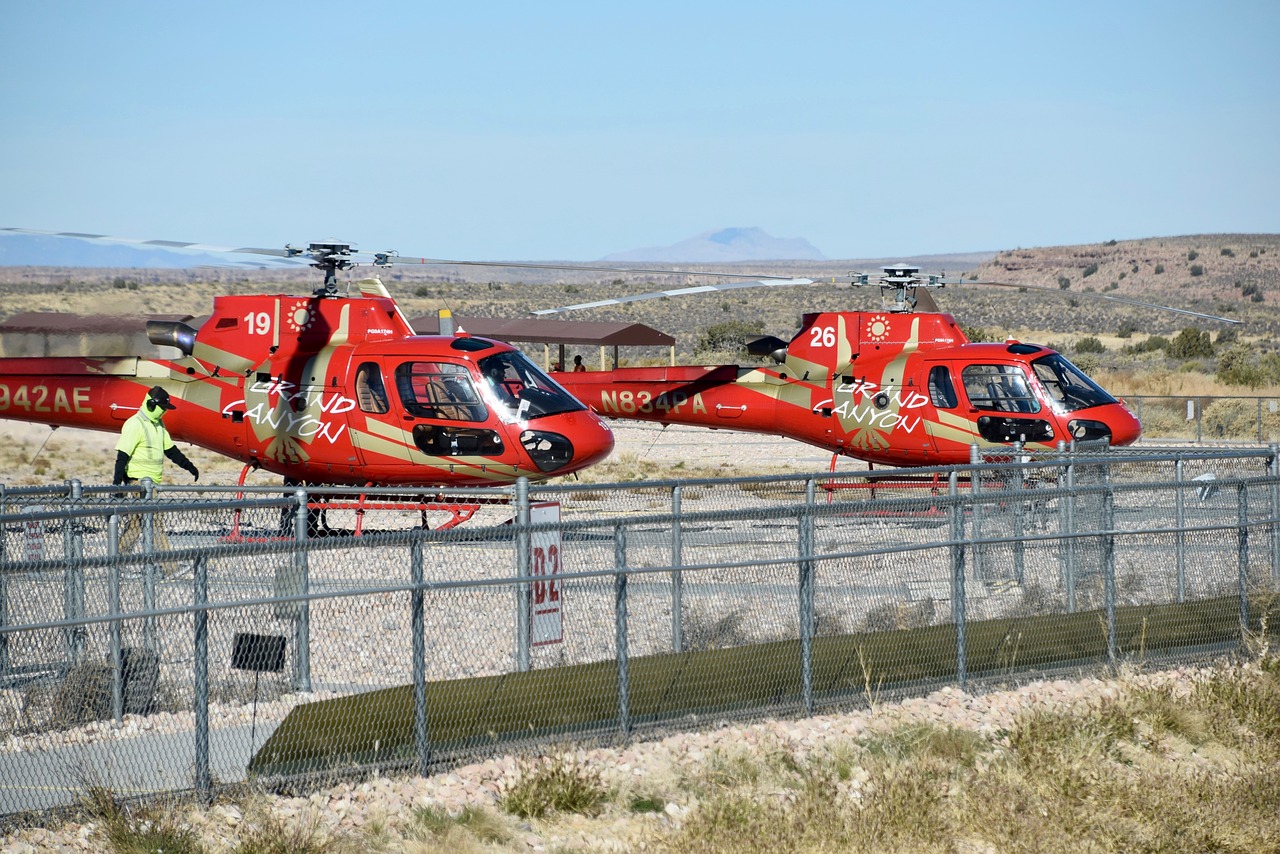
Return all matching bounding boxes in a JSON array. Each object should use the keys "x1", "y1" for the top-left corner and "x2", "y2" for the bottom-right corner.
[{"x1": 0, "y1": 448, "x2": 1280, "y2": 814}]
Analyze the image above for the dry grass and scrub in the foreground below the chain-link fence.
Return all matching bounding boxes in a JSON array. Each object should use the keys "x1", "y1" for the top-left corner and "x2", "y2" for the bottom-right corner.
[{"x1": 10, "y1": 654, "x2": 1280, "y2": 854}]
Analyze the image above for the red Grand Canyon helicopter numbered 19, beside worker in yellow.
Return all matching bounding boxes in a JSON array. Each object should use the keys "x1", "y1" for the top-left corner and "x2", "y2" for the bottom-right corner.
[{"x1": 0, "y1": 229, "x2": 613, "y2": 521}]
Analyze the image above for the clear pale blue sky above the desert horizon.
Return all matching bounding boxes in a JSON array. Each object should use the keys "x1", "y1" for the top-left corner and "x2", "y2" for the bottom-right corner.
[{"x1": 0, "y1": 0, "x2": 1280, "y2": 260}]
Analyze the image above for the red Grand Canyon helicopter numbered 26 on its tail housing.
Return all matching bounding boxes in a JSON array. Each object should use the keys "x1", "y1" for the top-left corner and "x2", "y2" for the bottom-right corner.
[{"x1": 535, "y1": 264, "x2": 1238, "y2": 466}]
